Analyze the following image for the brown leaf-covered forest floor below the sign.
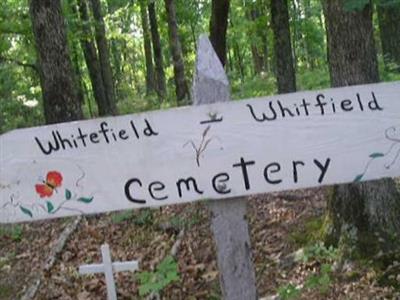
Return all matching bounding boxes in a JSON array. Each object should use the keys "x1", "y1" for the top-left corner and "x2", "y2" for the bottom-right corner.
[{"x1": 0, "y1": 189, "x2": 400, "y2": 300}]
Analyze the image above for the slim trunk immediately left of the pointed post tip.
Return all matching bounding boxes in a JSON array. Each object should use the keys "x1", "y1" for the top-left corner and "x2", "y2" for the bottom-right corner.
[{"x1": 164, "y1": 0, "x2": 190, "y2": 106}]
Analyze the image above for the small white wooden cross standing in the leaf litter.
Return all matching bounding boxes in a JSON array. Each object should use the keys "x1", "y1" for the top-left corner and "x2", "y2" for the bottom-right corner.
[{"x1": 79, "y1": 244, "x2": 139, "y2": 300}]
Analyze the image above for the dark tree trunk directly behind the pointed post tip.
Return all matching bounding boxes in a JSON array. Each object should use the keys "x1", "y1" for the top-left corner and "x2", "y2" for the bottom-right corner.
[{"x1": 210, "y1": 0, "x2": 230, "y2": 66}]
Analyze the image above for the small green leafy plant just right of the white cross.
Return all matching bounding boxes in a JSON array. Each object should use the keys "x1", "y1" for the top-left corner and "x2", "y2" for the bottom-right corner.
[{"x1": 136, "y1": 256, "x2": 179, "y2": 296}]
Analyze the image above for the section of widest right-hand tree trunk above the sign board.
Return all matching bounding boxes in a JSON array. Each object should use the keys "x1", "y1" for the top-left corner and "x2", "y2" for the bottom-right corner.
[{"x1": 324, "y1": 0, "x2": 379, "y2": 87}]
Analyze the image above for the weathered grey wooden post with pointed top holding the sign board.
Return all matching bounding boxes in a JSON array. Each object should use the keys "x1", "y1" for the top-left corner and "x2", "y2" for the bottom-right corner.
[{"x1": 193, "y1": 35, "x2": 257, "y2": 300}]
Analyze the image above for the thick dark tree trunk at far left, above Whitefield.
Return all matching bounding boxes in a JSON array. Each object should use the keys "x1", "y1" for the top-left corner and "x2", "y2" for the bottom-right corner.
[{"x1": 30, "y1": 0, "x2": 82, "y2": 124}]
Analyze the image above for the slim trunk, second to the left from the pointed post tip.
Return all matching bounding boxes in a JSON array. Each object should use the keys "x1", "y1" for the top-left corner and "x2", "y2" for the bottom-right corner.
[{"x1": 148, "y1": 1, "x2": 167, "y2": 99}]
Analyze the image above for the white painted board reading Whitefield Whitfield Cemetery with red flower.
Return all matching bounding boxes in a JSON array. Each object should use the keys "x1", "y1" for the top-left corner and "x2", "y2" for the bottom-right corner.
[{"x1": 0, "y1": 82, "x2": 400, "y2": 223}]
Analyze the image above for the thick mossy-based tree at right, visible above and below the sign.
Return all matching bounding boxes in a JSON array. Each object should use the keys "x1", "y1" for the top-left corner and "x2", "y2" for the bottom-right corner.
[{"x1": 324, "y1": 0, "x2": 400, "y2": 255}]
